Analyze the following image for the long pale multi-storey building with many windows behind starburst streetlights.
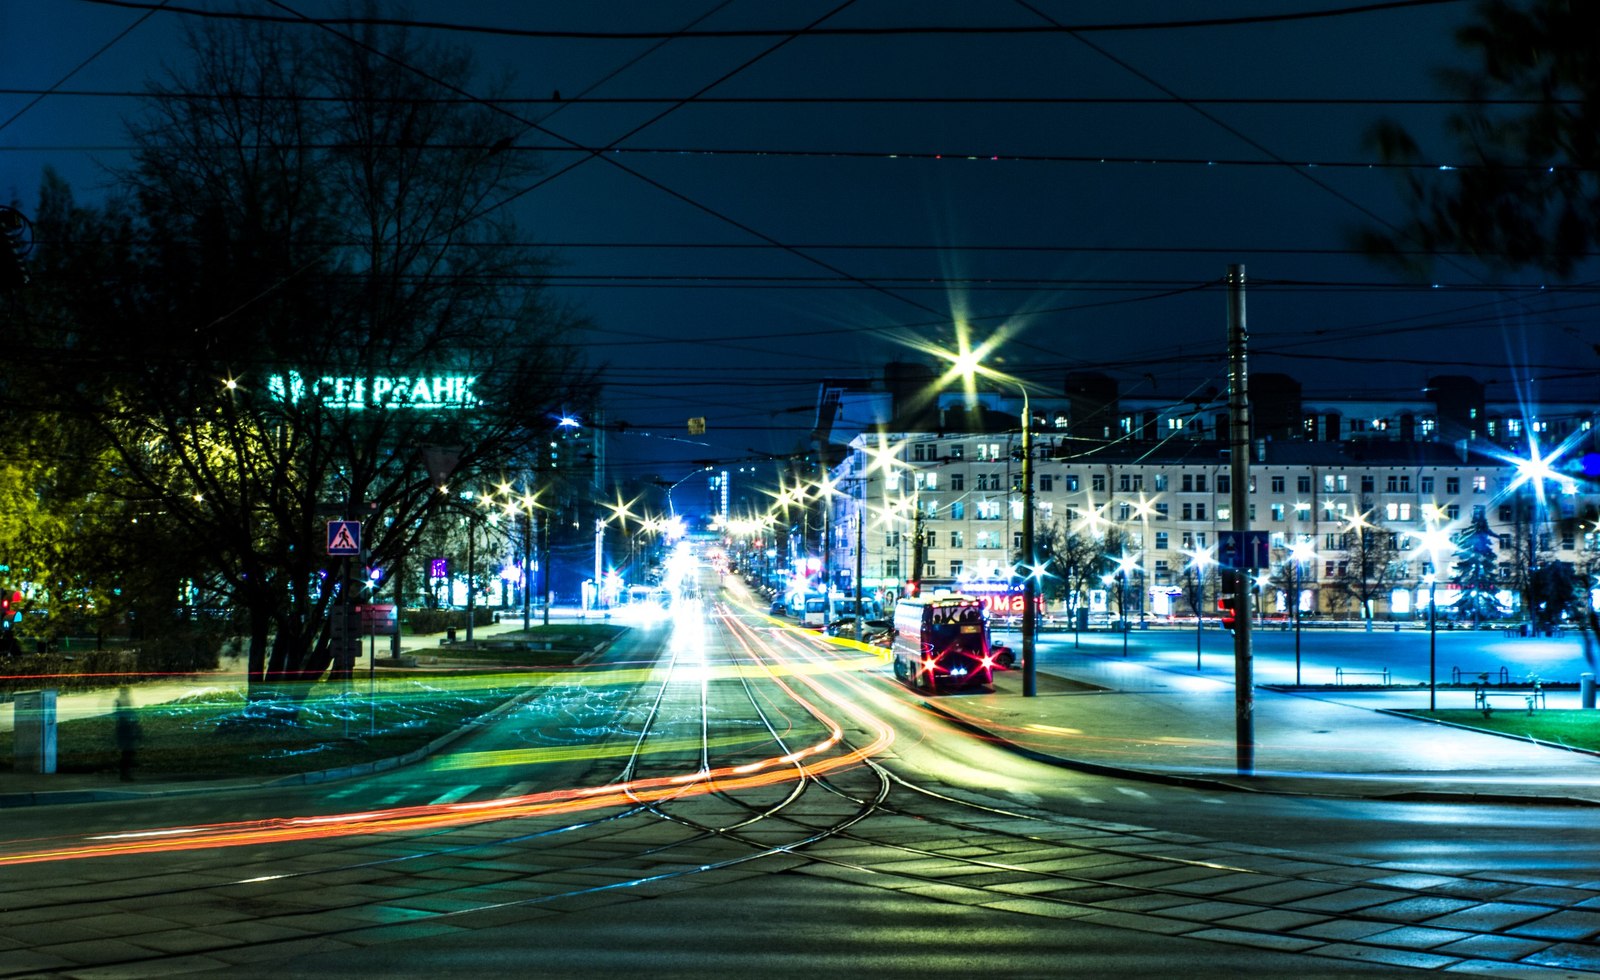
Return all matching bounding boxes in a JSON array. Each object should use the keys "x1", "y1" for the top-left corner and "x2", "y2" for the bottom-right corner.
[{"x1": 789, "y1": 365, "x2": 1600, "y2": 618}]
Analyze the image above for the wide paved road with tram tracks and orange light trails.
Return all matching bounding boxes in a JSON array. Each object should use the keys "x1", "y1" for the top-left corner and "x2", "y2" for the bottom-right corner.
[{"x1": 0, "y1": 582, "x2": 1600, "y2": 977}]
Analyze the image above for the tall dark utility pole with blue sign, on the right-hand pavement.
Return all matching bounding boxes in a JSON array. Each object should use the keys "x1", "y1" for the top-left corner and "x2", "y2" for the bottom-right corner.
[{"x1": 1227, "y1": 266, "x2": 1256, "y2": 775}]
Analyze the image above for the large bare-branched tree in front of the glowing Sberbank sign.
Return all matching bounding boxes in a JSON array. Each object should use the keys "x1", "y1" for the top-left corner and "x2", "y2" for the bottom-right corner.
[{"x1": 28, "y1": 11, "x2": 584, "y2": 693}]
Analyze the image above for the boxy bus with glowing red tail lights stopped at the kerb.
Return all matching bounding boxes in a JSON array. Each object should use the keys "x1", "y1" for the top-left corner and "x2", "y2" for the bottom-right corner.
[{"x1": 893, "y1": 592, "x2": 995, "y2": 692}]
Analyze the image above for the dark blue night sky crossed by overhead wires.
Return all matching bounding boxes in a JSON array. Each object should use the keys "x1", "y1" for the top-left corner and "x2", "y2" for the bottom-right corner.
[{"x1": 0, "y1": 0, "x2": 1600, "y2": 476}]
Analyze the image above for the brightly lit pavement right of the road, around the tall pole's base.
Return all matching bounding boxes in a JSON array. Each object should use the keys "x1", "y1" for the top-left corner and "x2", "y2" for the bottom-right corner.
[{"x1": 928, "y1": 657, "x2": 1600, "y2": 804}]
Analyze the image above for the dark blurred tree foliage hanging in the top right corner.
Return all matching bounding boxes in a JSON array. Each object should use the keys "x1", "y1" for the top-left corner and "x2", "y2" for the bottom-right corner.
[{"x1": 1363, "y1": 0, "x2": 1600, "y2": 275}]
